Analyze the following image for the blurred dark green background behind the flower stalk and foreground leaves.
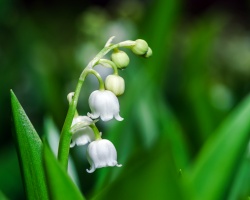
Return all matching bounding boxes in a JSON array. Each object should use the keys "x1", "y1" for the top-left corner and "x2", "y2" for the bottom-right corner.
[{"x1": 0, "y1": 0, "x2": 250, "y2": 199}]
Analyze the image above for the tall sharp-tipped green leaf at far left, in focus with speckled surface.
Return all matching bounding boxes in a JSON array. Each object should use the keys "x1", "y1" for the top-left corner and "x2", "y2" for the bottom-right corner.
[{"x1": 10, "y1": 91, "x2": 48, "y2": 200}]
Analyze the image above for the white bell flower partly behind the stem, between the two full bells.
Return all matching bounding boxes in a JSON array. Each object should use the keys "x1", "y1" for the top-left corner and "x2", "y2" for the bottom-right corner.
[{"x1": 70, "y1": 116, "x2": 95, "y2": 147}]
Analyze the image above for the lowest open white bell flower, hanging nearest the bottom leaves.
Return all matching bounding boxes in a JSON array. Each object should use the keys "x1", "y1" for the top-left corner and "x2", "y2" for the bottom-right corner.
[{"x1": 87, "y1": 139, "x2": 122, "y2": 173}]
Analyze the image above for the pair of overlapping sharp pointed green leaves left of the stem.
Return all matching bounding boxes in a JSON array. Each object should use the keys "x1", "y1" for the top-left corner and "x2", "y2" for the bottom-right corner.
[{"x1": 11, "y1": 91, "x2": 84, "y2": 200}]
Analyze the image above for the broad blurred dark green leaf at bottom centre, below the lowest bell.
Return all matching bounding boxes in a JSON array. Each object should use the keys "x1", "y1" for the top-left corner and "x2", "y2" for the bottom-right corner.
[{"x1": 93, "y1": 142, "x2": 185, "y2": 200}]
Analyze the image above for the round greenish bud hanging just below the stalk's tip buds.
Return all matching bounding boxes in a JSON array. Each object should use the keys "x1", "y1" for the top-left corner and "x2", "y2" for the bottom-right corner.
[{"x1": 111, "y1": 50, "x2": 129, "y2": 69}]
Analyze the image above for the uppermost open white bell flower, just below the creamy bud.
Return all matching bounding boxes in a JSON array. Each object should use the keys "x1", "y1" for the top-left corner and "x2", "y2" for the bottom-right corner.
[{"x1": 88, "y1": 90, "x2": 123, "y2": 121}]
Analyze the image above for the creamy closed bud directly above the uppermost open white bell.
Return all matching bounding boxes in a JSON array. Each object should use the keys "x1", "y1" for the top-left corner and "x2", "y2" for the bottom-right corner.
[{"x1": 105, "y1": 75, "x2": 125, "y2": 96}]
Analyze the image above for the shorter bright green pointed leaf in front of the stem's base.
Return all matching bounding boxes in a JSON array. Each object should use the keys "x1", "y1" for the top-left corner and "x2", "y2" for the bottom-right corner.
[{"x1": 43, "y1": 143, "x2": 85, "y2": 200}]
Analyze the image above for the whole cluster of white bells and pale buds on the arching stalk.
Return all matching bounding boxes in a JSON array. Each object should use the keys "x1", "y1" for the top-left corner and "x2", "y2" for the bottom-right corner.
[{"x1": 68, "y1": 37, "x2": 152, "y2": 173}]
